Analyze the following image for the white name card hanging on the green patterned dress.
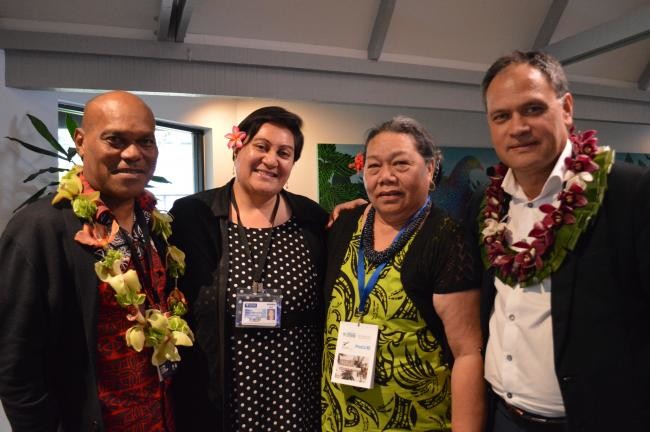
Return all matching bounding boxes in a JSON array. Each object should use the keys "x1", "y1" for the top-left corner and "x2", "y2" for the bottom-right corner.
[{"x1": 331, "y1": 321, "x2": 379, "y2": 389}]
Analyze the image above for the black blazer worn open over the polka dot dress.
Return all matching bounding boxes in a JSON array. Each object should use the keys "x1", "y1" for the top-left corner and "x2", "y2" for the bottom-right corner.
[{"x1": 170, "y1": 180, "x2": 328, "y2": 432}]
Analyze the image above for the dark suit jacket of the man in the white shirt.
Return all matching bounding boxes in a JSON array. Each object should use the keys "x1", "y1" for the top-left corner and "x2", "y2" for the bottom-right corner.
[{"x1": 481, "y1": 162, "x2": 650, "y2": 432}]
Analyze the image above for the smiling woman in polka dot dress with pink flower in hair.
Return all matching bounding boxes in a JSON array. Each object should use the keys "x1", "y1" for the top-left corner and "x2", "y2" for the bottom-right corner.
[{"x1": 172, "y1": 107, "x2": 327, "y2": 432}]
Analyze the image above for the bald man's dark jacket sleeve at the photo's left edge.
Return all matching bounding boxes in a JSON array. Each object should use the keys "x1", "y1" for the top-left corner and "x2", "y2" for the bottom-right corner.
[{"x1": 0, "y1": 207, "x2": 60, "y2": 431}]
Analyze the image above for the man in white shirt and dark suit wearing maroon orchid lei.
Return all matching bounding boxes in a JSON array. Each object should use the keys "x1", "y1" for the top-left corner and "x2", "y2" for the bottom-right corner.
[{"x1": 479, "y1": 52, "x2": 650, "y2": 432}]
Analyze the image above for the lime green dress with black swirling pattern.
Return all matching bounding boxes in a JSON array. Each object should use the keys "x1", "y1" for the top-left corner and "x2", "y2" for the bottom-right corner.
[{"x1": 321, "y1": 220, "x2": 451, "y2": 432}]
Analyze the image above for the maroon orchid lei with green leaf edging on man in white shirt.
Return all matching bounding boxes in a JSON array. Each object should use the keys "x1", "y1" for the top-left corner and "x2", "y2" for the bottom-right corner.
[{"x1": 478, "y1": 129, "x2": 614, "y2": 287}]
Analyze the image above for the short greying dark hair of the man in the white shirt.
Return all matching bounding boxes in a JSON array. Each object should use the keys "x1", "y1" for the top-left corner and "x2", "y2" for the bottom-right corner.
[{"x1": 481, "y1": 51, "x2": 569, "y2": 103}]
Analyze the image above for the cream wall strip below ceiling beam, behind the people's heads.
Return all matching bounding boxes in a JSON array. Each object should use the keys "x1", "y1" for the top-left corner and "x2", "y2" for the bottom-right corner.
[{"x1": 54, "y1": 93, "x2": 650, "y2": 207}]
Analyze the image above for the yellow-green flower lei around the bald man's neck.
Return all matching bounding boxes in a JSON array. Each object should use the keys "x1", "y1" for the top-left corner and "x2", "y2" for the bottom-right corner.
[{"x1": 52, "y1": 165, "x2": 194, "y2": 366}]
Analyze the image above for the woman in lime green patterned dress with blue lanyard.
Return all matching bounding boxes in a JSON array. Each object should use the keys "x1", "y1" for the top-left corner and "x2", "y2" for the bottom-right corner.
[{"x1": 321, "y1": 117, "x2": 484, "y2": 432}]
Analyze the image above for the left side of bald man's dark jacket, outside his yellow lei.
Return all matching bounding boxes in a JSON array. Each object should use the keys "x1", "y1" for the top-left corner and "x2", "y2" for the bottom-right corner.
[{"x1": 0, "y1": 196, "x2": 103, "y2": 431}]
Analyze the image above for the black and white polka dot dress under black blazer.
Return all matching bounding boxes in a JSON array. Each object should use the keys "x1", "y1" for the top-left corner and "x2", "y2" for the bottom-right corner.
[{"x1": 227, "y1": 218, "x2": 322, "y2": 432}]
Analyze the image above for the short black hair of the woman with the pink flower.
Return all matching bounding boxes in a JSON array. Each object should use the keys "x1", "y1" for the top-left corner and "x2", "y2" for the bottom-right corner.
[{"x1": 238, "y1": 106, "x2": 305, "y2": 162}]
